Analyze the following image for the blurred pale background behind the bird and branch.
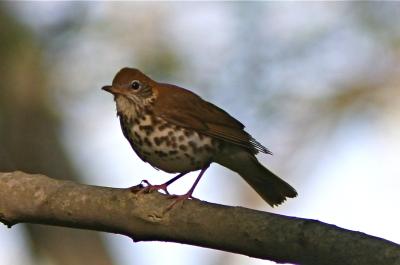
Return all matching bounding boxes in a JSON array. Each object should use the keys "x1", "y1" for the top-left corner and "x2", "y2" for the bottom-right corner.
[{"x1": 0, "y1": 2, "x2": 400, "y2": 265}]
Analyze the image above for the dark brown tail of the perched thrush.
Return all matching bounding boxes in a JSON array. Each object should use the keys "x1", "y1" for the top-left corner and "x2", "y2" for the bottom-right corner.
[{"x1": 218, "y1": 152, "x2": 297, "y2": 207}]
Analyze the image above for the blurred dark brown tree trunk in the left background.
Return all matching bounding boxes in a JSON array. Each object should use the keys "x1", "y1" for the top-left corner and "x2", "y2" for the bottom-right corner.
[{"x1": 0, "y1": 4, "x2": 112, "y2": 265}]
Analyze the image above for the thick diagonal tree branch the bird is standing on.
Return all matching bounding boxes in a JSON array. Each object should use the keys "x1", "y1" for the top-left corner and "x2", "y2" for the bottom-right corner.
[{"x1": 0, "y1": 172, "x2": 400, "y2": 265}]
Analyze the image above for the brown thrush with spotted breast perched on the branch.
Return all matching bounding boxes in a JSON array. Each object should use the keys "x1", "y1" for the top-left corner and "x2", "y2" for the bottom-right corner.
[{"x1": 102, "y1": 68, "x2": 297, "y2": 206}]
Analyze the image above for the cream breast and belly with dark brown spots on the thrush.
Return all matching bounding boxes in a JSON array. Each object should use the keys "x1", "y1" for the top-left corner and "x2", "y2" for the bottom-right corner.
[{"x1": 116, "y1": 97, "x2": 221, "y2": 173}]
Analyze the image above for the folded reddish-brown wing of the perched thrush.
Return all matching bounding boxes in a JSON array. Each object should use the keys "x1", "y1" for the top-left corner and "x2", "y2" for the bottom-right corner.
[{"x1": 154, "y1": 84, "x2": 271, "y2": 154}]
